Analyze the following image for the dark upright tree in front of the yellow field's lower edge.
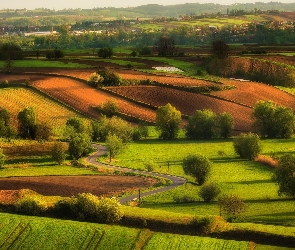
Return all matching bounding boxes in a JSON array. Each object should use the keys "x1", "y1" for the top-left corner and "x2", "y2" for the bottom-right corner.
[{"x1": 17, "y1": 107, "x2": 37, "y2": 138}]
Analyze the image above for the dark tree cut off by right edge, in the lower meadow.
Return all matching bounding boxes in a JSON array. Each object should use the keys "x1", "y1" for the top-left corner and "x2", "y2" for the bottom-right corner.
[{"x1": 274, "y1": 154, "x2": 295, "y2": 198}]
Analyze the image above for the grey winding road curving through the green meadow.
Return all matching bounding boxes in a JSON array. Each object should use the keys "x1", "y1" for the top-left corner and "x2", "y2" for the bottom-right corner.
[{"x1": 85, "y1": 144, "x2": 186, "y2": 204}]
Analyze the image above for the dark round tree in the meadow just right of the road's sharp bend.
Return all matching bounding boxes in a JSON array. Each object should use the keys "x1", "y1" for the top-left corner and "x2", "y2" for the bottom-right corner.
[{"x1": 182, "y1": 155, "x2": 212, "y2": 185}]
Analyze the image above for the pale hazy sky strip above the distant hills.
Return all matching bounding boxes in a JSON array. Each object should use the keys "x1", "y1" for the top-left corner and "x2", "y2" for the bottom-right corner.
[{"x1": 0, "y1": 0, "x2": 295, "y2": 10}]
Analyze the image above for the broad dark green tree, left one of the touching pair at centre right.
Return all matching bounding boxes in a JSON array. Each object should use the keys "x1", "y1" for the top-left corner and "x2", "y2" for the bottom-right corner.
[{"x1": 186, "y1": 109, "x2": 217, "y2": 139}]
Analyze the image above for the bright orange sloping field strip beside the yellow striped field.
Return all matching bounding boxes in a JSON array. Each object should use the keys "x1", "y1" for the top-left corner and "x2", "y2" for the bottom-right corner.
[{"x1": 34, "y1": 77, "x2": 155, "y2": 121}]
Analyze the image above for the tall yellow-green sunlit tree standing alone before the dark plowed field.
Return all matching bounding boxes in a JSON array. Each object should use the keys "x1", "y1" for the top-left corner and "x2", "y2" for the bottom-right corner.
[{"x1": 156, "y1": 103, "x2": 181, "y2": 140}]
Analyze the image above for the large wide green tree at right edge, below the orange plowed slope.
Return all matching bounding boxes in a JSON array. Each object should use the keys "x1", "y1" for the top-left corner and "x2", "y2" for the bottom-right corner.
[{"x1": 252, "y1": 101, "x2": 295, "y2": 138}]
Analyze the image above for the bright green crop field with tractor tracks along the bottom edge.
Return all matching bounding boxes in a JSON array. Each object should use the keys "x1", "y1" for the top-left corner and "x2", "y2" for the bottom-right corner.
[{"x1": 0, "y1": 214, "x2": 249, "y2": 250}]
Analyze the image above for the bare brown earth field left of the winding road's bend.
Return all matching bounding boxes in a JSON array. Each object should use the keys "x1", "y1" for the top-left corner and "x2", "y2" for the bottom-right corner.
[{"x1": 0, "y1": 176, "x2": 156, "y2": 203}]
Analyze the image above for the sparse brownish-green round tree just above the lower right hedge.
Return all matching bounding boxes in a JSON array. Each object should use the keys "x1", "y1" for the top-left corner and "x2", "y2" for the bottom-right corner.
[{"x1": 219, "y1": 195, "x2": 246, "y2": 221}]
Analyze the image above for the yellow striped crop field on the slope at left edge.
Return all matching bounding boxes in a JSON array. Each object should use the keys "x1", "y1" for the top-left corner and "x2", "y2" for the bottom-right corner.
[{"x1": 0, "y1": 88, "x2": 85, "y2": 127}]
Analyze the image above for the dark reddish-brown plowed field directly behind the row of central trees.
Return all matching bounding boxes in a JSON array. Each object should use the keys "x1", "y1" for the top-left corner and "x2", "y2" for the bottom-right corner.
[{"x1": 109, "y1": 86, "x2": 252, "y2": 131}]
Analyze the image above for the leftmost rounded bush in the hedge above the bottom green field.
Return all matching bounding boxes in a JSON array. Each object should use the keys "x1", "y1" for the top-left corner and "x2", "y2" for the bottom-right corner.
[{"x1": 15, "y1": 197, "x2": 46, "y2": 215}]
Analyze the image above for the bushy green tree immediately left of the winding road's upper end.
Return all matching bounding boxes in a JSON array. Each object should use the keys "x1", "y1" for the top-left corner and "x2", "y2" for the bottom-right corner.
[{"x1": 69, "y1": 133, "x2": 91, "y2": 160}]
